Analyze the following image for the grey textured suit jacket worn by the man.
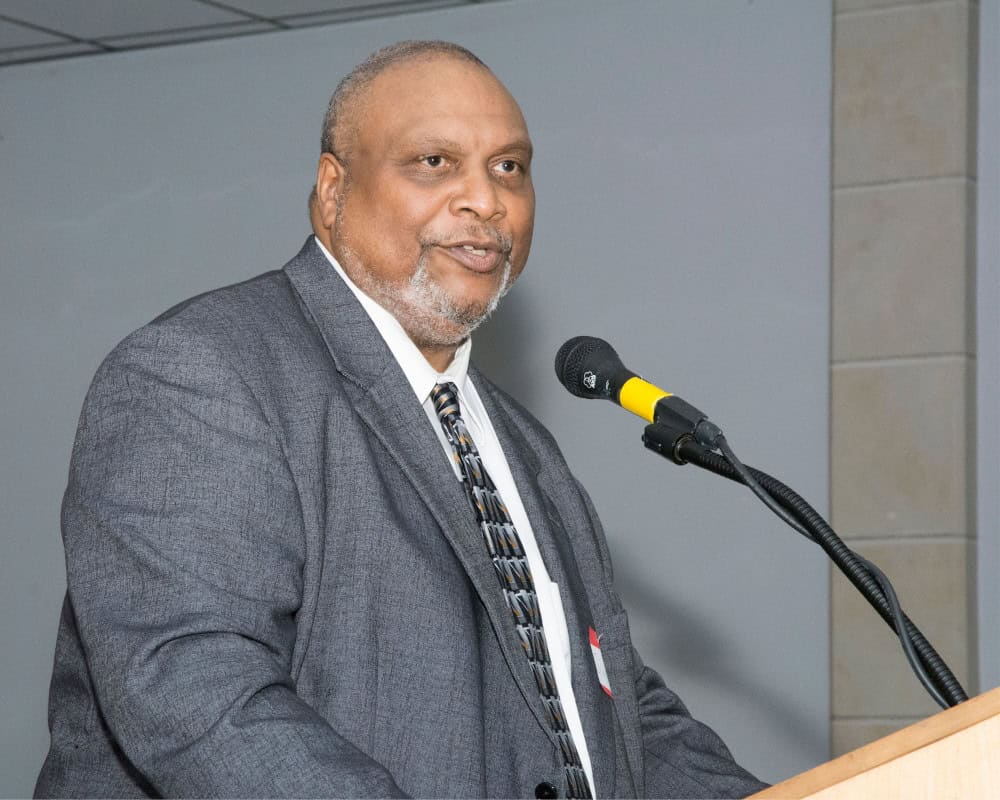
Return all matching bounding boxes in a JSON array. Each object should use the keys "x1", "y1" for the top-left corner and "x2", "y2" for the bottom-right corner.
[{"x1": 36, "y1": 237, "x2": 762, "y2": 797}]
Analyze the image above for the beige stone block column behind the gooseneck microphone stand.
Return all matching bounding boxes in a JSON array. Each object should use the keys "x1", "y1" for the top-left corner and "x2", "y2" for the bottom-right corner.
[{"x1": 830, "y1": 0, "x2": 979, "y2": 755}]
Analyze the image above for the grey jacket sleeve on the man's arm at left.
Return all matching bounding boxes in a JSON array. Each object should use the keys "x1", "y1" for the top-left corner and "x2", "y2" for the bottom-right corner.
[{"x1": 63, "y1": 324, "x2": 403, "y2": 797}]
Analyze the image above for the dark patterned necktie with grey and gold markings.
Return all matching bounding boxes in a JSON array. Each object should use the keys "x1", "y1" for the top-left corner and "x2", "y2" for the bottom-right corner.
[{"x1": 431, "y1": 383, "x2": 592, "y2": 798}]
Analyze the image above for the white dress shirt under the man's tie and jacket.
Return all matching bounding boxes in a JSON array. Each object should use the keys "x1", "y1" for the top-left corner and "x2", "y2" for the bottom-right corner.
[{"x1": 316, "y1": 238, "x2": 594, "y2": 787}]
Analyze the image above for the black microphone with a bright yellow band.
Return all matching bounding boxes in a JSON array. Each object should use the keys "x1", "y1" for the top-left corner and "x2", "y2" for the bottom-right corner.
[{"x1": 556, "y1": 336, "x2": 722, "y2": 448}]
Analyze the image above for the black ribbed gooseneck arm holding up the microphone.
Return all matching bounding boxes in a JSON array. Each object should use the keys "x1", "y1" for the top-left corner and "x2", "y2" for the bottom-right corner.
[{"x1": 672, "y1": 438, "x2": 968, "y2": 705}]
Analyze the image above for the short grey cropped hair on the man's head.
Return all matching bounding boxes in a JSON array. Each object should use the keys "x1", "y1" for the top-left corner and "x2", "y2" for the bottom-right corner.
[{"x1": 320, "y1": 40, "x2": 492, "y2": 164}]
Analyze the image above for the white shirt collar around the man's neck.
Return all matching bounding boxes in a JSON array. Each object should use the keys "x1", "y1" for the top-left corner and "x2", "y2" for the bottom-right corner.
[{"x1": 313, "y1": 236, "x2": 472, "y2": 405}]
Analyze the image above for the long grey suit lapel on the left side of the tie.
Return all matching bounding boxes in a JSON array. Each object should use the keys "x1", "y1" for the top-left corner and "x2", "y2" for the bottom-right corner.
[{"x1": 284, "y1": 237, "x2": 558, "y2": 747}]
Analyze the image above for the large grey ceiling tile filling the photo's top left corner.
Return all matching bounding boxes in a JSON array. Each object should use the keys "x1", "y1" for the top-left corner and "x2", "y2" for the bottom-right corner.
[{"x1": 3, "y1": 0, "x2": 246, "y2": 39}]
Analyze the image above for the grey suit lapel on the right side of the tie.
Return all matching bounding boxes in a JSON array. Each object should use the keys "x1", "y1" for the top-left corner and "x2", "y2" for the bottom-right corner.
[{"x1": 471, "y1": 367, "x2": 616, "y2": 797}]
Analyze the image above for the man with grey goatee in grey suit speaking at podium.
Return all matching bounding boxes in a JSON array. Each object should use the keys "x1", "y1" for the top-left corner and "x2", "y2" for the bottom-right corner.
[{"x1": 36, "y1": 42, "x2": 763, "y2": 797}]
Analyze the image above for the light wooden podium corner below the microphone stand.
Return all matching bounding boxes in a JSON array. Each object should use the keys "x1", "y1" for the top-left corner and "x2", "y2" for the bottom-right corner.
[{"x1": 752, "y1": 688, "x2": 1000, "y2": 800}]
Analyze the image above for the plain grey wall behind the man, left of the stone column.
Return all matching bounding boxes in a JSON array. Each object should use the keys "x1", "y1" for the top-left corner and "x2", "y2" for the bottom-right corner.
[{"x1": 0, "y1": 0, "x2": 831, "y2": 795}]
